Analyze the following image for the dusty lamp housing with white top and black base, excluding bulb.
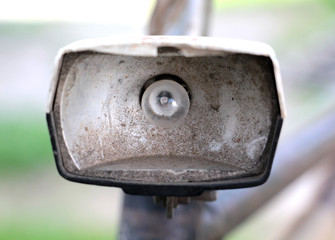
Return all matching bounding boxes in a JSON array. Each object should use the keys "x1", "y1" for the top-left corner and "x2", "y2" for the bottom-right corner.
[{"x1": 47, "y1": 36, "x2": 285, "y2": 196}]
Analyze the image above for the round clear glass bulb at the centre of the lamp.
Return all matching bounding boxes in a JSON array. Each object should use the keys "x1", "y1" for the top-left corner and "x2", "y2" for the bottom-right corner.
[{"x1": 141, "y1": 80, "x2": 190, "y2": 128}]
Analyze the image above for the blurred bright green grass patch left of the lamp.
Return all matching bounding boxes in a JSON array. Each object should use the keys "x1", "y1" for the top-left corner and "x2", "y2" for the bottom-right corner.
[{"x1": 0, "y1": 111, "x2": 52, "y2": 172}]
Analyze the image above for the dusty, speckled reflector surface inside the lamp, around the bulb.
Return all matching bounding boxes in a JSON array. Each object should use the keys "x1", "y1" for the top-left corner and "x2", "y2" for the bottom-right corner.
[{"x1": 55, "y1": 49, "x2": 279, "y2": 183}]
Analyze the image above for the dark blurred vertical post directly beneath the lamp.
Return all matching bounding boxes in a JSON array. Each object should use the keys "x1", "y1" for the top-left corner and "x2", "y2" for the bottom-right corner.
[{"x1": 119, "y1": 194, "x2": 201, "y2": 240}]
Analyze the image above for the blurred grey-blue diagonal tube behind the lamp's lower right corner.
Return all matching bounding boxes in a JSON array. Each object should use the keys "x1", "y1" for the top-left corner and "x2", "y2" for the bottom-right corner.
[{"x1": 198, "y1": 111, "x2": 335, "y2": 240}]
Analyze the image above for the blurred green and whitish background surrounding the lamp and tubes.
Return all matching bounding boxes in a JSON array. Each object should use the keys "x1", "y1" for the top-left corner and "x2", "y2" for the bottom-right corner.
[{"x1": 0, "y1": 0, "x2": 335, "y2": 239}]
